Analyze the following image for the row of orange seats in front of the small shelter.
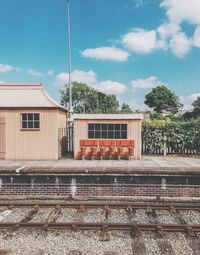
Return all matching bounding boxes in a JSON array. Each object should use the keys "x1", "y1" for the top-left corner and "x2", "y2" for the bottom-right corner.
[{"x1": 80, "y1": 140, "x2": 134, "y2": 159}]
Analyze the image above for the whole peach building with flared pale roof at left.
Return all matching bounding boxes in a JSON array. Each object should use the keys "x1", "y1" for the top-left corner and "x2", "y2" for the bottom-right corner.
[{"x1": 0, "y1": 84, "x2": 67, "y2": 160}]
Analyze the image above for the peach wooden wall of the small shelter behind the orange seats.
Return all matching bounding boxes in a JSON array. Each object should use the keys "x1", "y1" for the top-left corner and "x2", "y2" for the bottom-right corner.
[{"x1": 74, "y1": 120, "x2": 141, "y2": 159}]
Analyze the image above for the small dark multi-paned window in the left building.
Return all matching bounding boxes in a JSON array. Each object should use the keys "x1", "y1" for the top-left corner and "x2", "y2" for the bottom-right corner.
[{"x1": 21, "y1": 113, "x2": 40, "y2": 129}]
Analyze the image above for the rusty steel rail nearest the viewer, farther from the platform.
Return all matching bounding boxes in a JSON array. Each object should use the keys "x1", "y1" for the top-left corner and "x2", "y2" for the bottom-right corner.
[{"x1": 0, "y1": 222, "x2": 200, "y2": 234}]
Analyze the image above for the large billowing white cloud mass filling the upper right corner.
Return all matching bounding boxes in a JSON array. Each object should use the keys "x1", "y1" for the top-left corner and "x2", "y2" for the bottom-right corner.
[{"x1": 119, "y1": 0, "x2": 200, "y2": 58}]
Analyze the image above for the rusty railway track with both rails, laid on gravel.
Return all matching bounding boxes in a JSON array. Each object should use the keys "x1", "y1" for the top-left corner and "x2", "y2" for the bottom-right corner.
[{"x1": 0, "y1": 202, "x2": 200, "y2": 236}]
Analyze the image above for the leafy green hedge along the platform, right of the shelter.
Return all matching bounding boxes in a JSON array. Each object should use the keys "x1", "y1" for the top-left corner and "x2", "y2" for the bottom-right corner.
[{"x1": 142, "y1": 119, "x2": 200, "y2": 155}]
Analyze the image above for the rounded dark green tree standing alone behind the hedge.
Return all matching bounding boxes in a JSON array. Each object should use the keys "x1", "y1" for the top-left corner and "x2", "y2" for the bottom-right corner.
[{"x1": 145, "y1": 85, "x2": 182, "y2": 114}]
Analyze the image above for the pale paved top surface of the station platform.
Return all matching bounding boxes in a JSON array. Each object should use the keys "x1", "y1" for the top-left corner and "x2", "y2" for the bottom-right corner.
[{"x1": 0, "y1": 156, "x2": 200, "y2": 173}]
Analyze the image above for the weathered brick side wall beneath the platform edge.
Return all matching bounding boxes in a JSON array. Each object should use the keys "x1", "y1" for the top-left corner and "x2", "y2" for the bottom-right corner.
[{"x1": 0, "y1": 173, "x2": 200, "y2": 197}]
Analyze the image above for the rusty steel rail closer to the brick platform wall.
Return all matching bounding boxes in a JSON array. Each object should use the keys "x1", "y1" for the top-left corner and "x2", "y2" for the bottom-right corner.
[{"x1": 0, "y1": 202, "x2": 200, "y2": 212}]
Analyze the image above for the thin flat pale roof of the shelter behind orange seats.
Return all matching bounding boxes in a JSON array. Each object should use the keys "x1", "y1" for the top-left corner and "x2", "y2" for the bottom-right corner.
[{"x1": 73, "y1": 114, "x2": 143, "y2": 120}]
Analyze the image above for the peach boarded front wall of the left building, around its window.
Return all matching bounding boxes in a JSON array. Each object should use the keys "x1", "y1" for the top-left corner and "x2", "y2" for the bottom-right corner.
[{"x1": 0, "y1": 109, "x2": 60, "y2": 160}]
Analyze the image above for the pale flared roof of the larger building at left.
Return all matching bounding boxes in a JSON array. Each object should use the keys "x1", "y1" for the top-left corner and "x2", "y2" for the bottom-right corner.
[{"x1": 0, "y1": 83, "x2": 67, "y2": 111}]
